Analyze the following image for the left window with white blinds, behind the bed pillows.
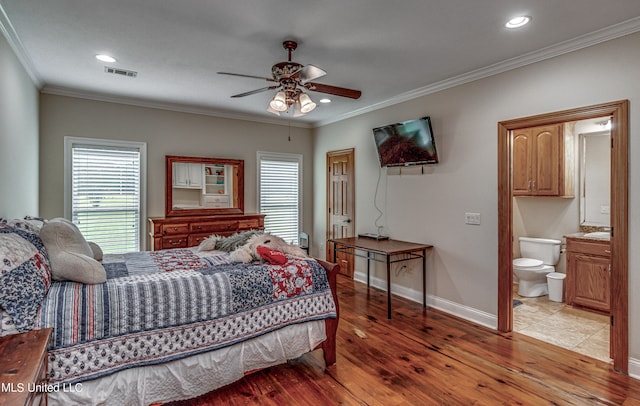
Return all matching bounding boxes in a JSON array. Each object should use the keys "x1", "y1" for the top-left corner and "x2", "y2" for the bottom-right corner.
[{"x1": 65, "y1": 137, "x2": 146, "y2": 254}]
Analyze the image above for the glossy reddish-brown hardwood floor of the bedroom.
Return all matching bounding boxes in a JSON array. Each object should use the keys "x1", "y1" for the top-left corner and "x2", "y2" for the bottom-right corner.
[{"x1": 169, "y1": 276, "x2": 640, "y2": 405}]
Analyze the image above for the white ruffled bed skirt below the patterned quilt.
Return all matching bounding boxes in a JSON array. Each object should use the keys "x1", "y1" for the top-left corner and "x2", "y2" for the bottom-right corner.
[{"x1": 49, "y1": 320, "x2": 326, "y2": 405}]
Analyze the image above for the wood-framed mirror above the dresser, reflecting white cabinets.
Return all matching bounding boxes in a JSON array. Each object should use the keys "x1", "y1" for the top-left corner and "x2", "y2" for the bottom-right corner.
[{"x1": 165, "y1": 155, "x2": 244, "y2": 217}]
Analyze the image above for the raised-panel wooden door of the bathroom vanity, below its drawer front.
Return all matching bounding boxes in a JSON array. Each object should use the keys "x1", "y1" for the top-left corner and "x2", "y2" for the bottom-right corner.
[{"x1": 571, "y1": 254, "x2": 610, "y2": 312}]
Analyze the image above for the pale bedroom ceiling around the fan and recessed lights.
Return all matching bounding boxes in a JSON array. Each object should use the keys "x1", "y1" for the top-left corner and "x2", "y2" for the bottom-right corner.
[{"x1": 0, "y1": 0, "x2": 640, "y2": 127}]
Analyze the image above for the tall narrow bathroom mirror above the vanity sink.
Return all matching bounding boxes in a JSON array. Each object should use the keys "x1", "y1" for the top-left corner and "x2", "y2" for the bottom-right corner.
[{"x1": 578, "y1": 131, "x2": 611, "y2": 227}]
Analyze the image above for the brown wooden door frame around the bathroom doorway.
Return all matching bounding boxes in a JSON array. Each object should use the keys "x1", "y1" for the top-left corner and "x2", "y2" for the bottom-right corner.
[{"x1": 498, "y1": 100, "x2": 629, "y2": 374}]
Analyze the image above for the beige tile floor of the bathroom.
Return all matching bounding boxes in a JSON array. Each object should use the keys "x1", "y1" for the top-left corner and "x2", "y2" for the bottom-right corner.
[{"x1": 513, "y1": 285, "x2": 611, "y2": 362}]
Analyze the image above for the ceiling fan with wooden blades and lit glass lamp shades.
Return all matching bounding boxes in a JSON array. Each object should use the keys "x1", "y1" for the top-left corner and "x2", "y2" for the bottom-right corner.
[{"x1": 218, "y1": 40, "x2": 362, "y2": 117}]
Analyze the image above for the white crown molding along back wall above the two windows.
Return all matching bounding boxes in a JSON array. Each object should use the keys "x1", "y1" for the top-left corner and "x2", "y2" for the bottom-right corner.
[{"x1": 40, "y1": 86, "x2": 313, "y2": 128}]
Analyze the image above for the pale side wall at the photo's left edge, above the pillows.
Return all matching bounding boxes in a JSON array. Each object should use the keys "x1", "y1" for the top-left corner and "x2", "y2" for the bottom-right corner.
[{"x1": 0, "y1": 31, "x2": 38, "y2": 218}]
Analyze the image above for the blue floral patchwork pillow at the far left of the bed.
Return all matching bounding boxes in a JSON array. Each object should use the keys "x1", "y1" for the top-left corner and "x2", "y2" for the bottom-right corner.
[{"x1": 0, "y1": 222, "x2": 51, "y2": 332}]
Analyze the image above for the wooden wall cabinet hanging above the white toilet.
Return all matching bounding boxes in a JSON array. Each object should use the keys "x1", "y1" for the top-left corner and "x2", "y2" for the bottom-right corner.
[{"x1": 513, "y1": 124, "x2": 574, "y2": 197}]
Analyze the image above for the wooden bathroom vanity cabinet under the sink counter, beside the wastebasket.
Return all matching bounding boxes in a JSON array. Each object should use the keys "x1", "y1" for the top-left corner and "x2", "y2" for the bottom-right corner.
[{"x1": 566, "y1": 238, "x2": 611, "y2": 313}]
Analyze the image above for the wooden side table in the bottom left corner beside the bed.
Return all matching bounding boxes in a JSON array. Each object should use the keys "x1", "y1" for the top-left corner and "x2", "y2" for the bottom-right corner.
[{"x1": 0, "y1": 328, "x2": 51, "y2": 406}]
